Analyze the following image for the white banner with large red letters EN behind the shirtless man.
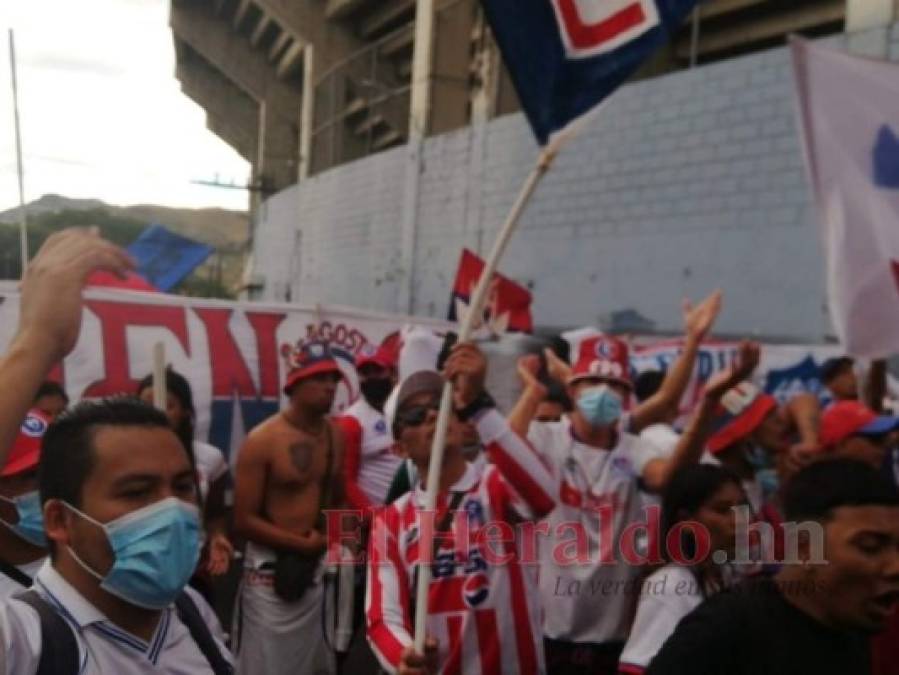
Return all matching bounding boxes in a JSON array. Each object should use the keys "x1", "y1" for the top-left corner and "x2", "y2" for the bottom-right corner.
[{"x1": 0, "y1": 283, "x2": 453, "y2": 459}]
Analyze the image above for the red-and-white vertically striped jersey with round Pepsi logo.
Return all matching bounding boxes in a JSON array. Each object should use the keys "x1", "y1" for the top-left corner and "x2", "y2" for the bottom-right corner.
[{"x1": 366, "y1": 410, "x2": 558, "y2": 675}]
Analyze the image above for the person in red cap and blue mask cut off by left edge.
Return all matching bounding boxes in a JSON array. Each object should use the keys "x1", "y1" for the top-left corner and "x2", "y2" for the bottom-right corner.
[{"x1": 0, "y1": 410, "x2": 48, "y2": 601}]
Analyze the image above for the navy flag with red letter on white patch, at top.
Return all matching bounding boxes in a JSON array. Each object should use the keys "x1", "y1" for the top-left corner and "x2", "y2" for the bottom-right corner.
[{"x1": 482, "y1": 0, "x2": 697, "y2": 145}]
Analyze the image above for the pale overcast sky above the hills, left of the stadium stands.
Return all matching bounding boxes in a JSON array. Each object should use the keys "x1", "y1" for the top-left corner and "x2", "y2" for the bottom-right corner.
[{"x1": 0, "y1": 0, "x2": 249, "y2": 210}]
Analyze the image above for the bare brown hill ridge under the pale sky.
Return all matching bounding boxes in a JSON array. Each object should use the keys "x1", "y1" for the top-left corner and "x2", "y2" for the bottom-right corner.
[{"x1": 0, "y1": 195, "x2": 250, "y2": 250}]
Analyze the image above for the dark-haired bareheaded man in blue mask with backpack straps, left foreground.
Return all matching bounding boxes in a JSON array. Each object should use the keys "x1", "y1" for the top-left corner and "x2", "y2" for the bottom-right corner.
[{"x1": 0, "y1": 398, "x2": 232, "y2": 675}]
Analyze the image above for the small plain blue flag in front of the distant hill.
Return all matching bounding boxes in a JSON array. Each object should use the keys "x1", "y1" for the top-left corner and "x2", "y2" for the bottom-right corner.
[{"x1": 128, "y1": 225, "x2": 215, "y2": 293}]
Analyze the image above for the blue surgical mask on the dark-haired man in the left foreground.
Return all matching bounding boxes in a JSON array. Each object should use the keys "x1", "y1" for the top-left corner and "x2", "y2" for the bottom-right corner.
[{"x1": 66, "y1": 497, "x2": 200, "y2": 610}]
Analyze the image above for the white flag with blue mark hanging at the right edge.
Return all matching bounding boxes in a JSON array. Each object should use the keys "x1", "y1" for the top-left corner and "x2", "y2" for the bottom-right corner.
[{"x1": 792, "y1": 39, "x2": 899, "y2": 358}]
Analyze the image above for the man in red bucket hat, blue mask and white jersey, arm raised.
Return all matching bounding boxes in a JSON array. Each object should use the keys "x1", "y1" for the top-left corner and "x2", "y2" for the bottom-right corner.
[{"x1": 529, "y1": 326, "x2": 758, "y2": 675}]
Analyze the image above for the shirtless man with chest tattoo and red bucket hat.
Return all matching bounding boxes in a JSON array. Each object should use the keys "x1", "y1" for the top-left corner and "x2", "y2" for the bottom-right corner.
[{"x1": 234, "y1": 343, "x2": 343, "y2": 675}]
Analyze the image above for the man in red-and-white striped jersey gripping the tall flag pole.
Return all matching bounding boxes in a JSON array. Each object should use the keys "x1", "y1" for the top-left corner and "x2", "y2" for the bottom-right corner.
[{"x1": 366, "y1": 344, "x2": 557, "y2": 675}]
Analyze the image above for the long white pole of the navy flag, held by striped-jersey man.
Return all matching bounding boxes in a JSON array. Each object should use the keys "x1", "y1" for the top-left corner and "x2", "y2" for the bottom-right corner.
[{"x1": 415, "y1": 145, "x2": 558, "y2": 654}]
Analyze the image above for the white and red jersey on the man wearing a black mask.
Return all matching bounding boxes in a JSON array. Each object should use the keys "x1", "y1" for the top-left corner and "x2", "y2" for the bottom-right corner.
[{"x1": 337, "y1": 397, "x2": 403, "y2": 511}]
